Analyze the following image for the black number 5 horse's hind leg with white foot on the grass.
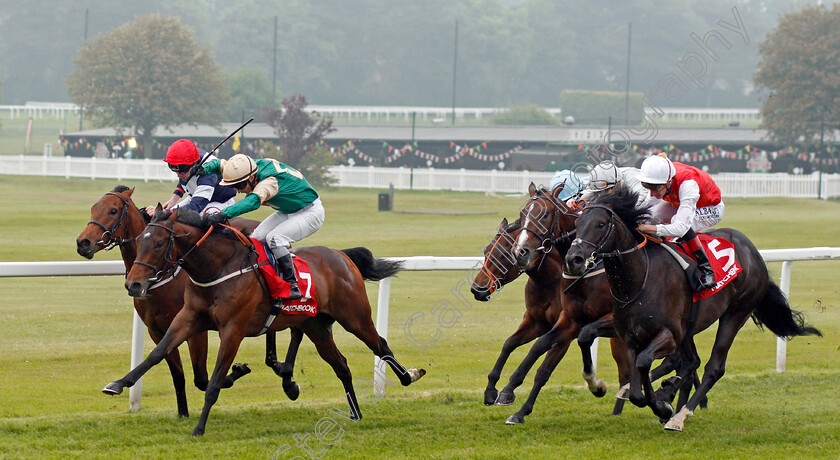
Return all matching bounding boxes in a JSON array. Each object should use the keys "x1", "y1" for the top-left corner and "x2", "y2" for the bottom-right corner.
[{"x1": 665, "y1": 316, "x2": 749, "y2": 431}]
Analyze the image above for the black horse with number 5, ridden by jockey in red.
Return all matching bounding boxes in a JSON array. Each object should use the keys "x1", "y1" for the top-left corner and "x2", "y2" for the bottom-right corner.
[{"x1": 566, "y1": 186, "x2": 822, "y2": 431}]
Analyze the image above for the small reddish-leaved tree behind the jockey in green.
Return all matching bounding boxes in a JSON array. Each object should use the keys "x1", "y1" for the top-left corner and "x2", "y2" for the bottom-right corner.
[{"x1": 266, "y1": 94, "x2": 335, "y2": 181}]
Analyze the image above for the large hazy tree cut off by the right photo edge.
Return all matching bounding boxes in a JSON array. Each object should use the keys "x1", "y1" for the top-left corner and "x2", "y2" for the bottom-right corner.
[{"x1": 755, "y1": 4, "x2": 840, "y2": 147}]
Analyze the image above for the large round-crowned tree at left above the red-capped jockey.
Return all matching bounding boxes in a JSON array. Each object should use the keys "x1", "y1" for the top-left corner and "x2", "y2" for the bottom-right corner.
[{"x1": 67, "y1": 14, "x2": 230, "y2": 158}]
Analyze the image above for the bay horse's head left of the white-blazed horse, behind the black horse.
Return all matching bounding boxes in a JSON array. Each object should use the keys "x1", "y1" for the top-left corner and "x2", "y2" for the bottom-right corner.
[{"x1": 470, "y1": 218, "x2": 521, "y2": 302}]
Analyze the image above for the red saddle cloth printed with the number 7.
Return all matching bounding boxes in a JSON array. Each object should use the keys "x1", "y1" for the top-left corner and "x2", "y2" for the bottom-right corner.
[{"x1": 251, "y1": 238, "x2": 318, "y2": 316}]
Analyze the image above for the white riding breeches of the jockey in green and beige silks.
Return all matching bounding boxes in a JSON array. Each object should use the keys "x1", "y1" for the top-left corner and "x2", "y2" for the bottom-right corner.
[{"x1": 251, "y1": 198, "x2": 324, "y2": 250}]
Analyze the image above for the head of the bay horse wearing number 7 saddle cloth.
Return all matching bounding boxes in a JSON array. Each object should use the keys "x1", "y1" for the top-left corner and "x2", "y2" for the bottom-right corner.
[{"x1": 125, "y1": 203, "x2": 194, "y2": 297}]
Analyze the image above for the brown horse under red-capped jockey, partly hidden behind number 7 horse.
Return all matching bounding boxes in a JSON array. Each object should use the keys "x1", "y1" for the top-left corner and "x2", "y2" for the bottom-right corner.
[{"x1": 76, "y1": 185, "x2": 302, "y2": 417}]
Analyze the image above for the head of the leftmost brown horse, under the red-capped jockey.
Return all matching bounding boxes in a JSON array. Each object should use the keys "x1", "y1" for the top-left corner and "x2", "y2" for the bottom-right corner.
[{"x1": 76, "y1": 185, "x2": 145, "y2": 259}]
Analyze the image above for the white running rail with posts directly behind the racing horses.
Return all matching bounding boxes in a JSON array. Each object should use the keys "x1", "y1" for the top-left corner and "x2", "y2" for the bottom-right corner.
[{"x1": 0, "y1": 247, "x2": 840, "y2": 410}]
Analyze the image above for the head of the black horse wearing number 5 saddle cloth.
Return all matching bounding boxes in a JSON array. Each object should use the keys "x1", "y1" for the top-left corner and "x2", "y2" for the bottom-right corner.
[{"x1": 566, "y1": 185, "x2": 650, "y2": 276}]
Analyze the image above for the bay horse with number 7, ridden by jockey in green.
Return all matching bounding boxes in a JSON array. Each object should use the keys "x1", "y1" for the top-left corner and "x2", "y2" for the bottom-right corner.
[{"x1": 102, "y1": 207, "x2": 426, "y2": 436}]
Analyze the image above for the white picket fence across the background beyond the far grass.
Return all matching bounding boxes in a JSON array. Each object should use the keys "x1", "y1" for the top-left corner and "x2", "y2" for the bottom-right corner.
[{"x1": 0, "y1": 155, "x2": 840, "y2": 199}]
